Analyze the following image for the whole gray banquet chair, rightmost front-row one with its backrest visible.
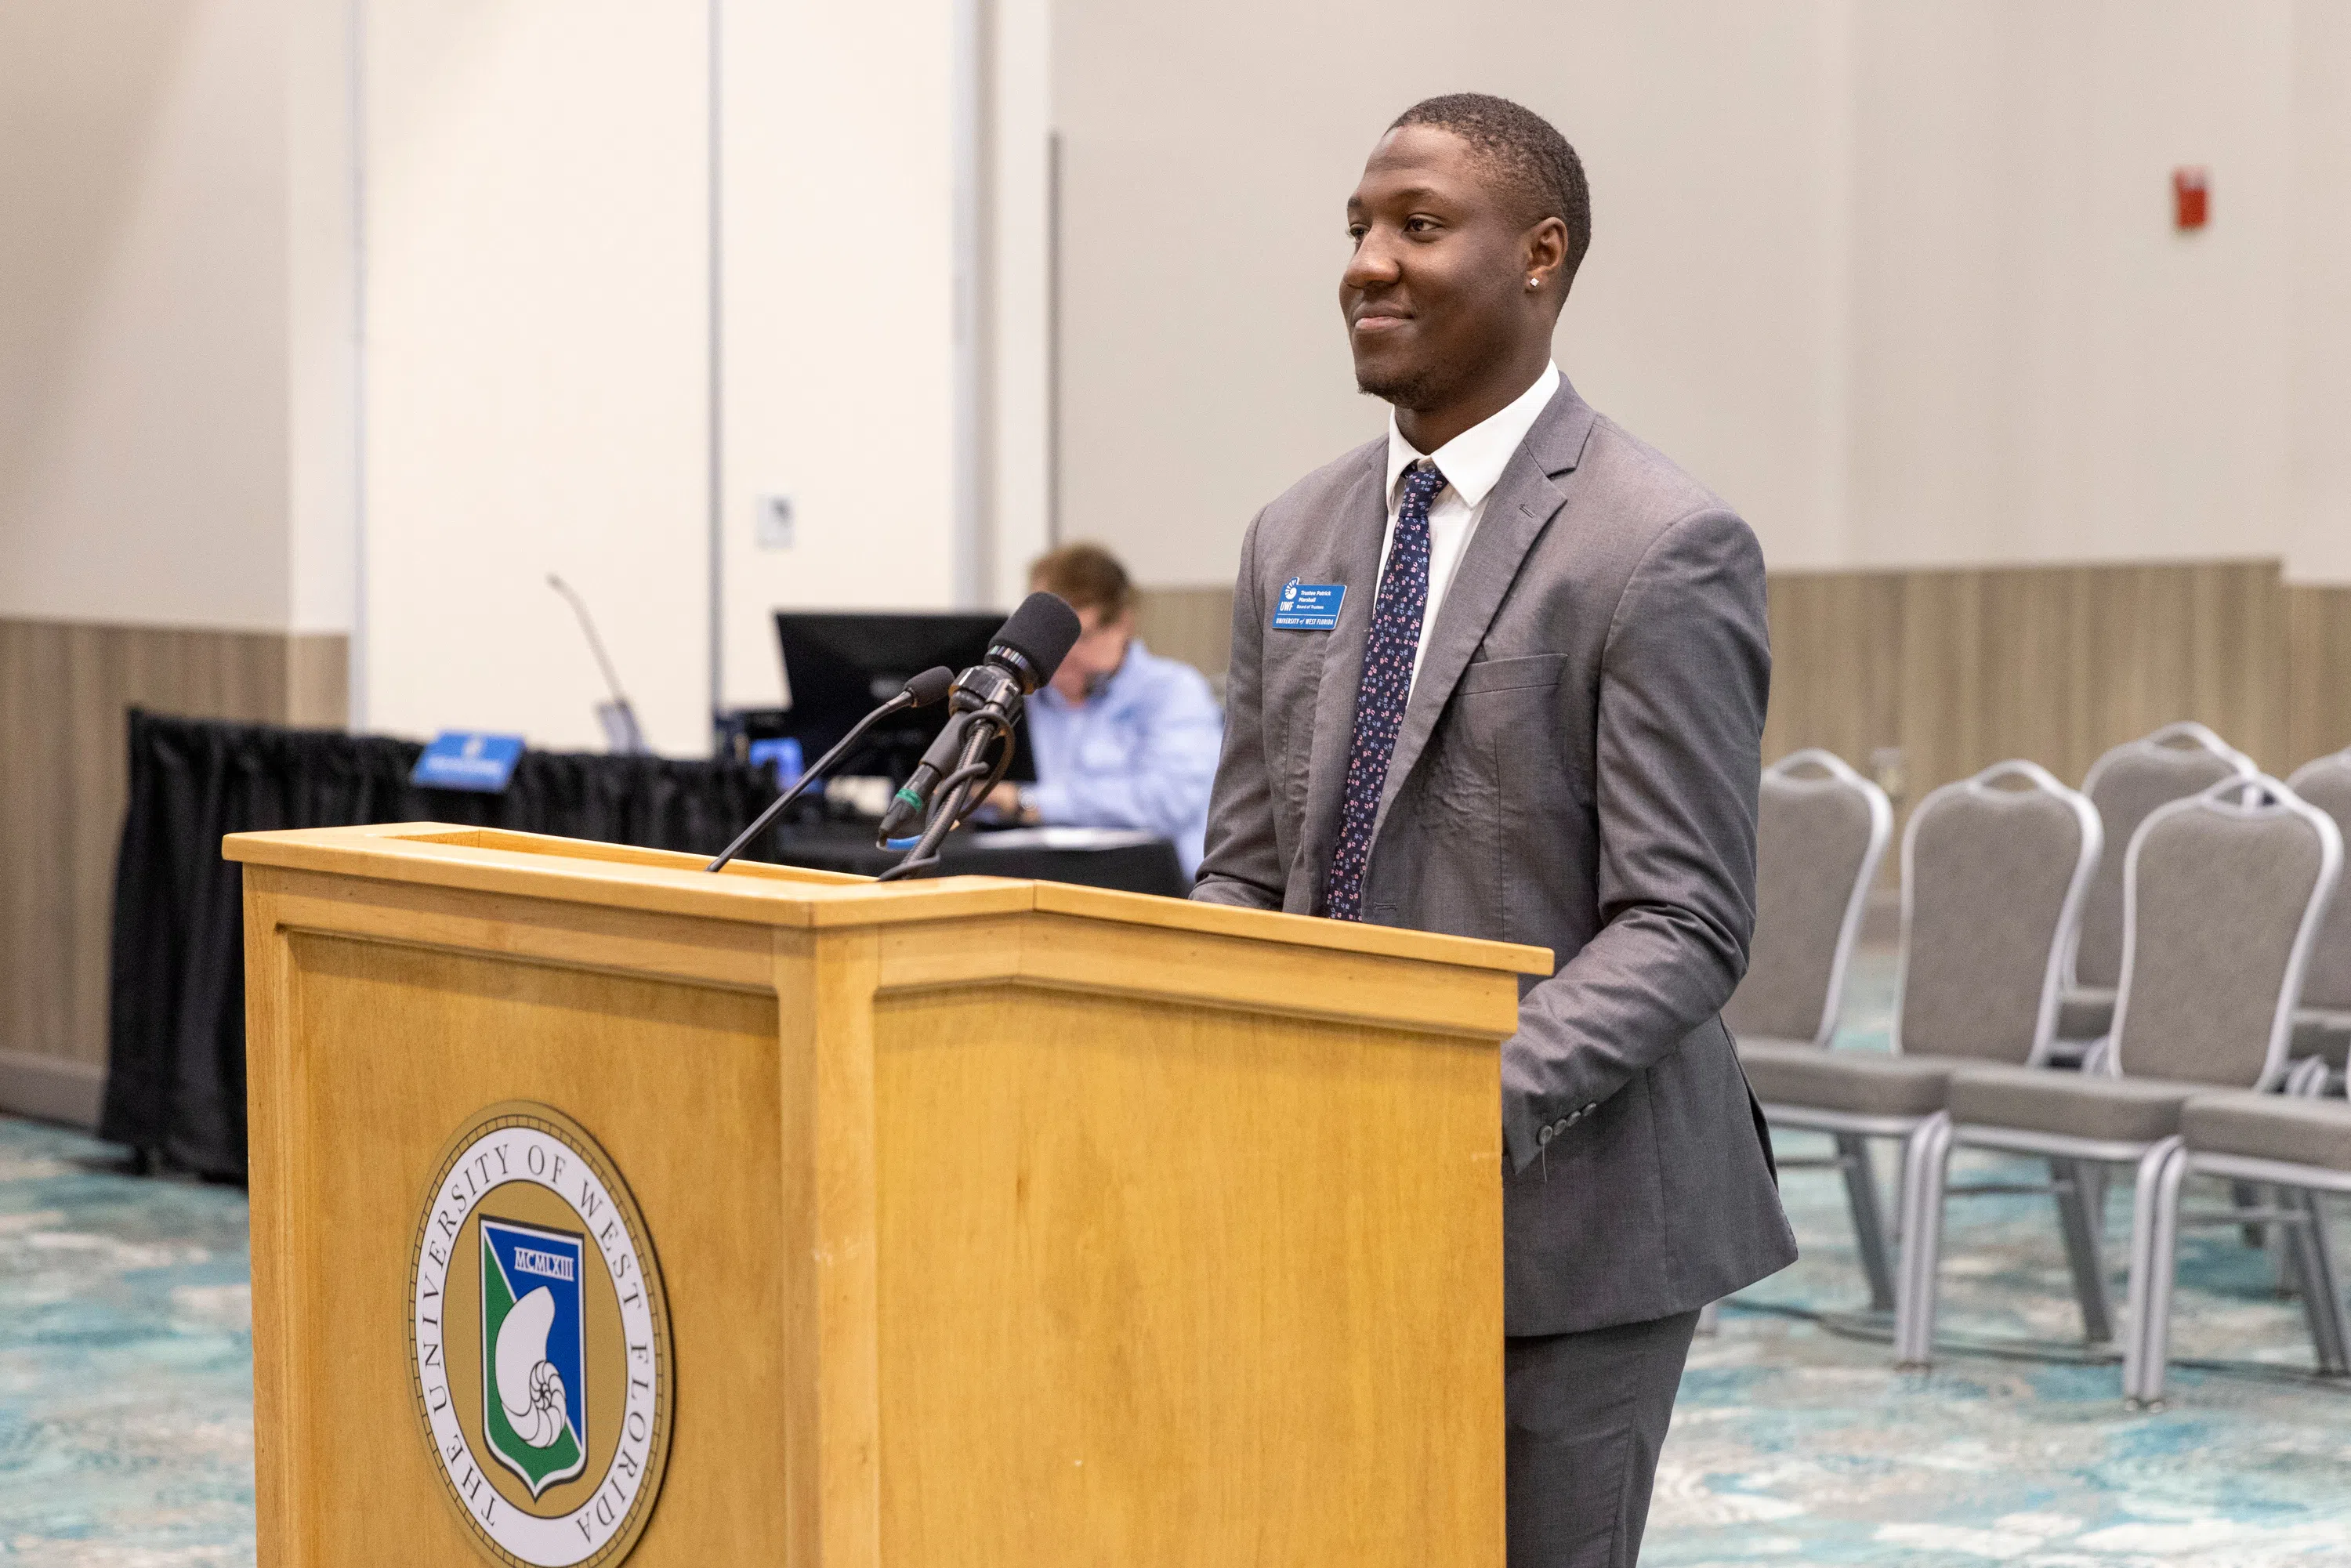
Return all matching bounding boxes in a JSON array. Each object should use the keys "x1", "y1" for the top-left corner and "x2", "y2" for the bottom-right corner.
[{"x1": 1895, "y1": 776, "x2": 2342, "y2": 1380}]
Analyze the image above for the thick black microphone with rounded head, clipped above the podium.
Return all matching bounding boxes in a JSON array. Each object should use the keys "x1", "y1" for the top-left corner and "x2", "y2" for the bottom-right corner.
[{"x1": 875, "y1": 592, "x2": 1084, "y2": 882}]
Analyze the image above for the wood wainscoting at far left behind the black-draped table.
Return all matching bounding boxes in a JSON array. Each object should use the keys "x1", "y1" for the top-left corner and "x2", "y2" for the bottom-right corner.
[{"x1": 0, "y1": 618, "x2": 348, "y2": 1114}]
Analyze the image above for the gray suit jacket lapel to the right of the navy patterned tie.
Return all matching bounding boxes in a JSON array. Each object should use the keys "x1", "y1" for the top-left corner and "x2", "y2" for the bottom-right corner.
[{"x1": 1373, "y1": 378, "x2": 1594, "y2": 846}]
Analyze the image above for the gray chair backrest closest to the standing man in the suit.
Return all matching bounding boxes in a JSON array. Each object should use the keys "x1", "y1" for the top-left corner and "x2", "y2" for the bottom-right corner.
[{"x1": 1723, "y1": 750, "x2": 1895, "y2": 1046}]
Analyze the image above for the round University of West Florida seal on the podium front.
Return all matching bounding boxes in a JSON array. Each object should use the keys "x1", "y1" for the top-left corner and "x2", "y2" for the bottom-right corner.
[{"x1": 409, "y1": 1100, "x2": 672, "y2": 1568}]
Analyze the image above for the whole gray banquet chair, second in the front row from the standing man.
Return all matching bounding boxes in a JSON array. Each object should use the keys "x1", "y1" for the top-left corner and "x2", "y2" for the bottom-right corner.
[{"x1": 1740, "y1": 762, "x2": 2099, "y2": 1309}]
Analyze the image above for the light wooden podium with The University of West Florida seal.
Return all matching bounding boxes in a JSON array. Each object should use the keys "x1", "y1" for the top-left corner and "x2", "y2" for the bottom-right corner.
[{"x1": 226, "y1": 823, "x2": 1549, "y2": 1568}]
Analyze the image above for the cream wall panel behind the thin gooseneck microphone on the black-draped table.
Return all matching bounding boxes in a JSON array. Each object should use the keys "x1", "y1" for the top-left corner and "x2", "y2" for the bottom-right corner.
[{"x1": 353, "y1": 0, "x2": 710, "y2": 752}]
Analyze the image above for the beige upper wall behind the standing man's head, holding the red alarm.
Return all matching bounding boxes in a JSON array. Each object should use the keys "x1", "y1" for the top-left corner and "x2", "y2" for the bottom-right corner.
[{"x1": 1056, "y1": 0, "x2": 2351, "y2": 583}]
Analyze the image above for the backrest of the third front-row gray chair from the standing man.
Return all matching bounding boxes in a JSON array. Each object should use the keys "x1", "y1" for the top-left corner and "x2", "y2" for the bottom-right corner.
[{"x1": 2106, "y1": 773, "x2": 2344, "y2": 1088}]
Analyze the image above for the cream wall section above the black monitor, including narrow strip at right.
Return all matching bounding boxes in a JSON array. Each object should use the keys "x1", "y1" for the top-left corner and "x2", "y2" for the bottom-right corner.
[{"x1": 719, "y1": 0, "x2": 1049, "y2": 705}]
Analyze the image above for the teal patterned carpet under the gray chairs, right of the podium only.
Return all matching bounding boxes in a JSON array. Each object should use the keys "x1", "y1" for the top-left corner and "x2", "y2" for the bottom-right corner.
[{"x1": 1641, "y1": 954, "x2": 2351, "y2": 1568}]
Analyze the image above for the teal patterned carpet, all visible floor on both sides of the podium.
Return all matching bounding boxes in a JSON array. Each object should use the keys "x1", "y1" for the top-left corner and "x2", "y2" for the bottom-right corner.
[{"x1": 0, "y1": 957, "x2": 2351, "y2": 1568}]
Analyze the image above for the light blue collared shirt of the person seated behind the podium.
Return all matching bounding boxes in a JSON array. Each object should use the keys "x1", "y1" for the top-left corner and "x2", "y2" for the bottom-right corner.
[{"x1": 1027, "y1": 642, "x2": 1225, "y2": 877}]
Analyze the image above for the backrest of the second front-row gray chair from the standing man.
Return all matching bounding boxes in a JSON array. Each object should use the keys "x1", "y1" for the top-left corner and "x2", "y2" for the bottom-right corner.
[{"x1": 1895, "y1": 762, "x2": 2102, "y2": 1063}]
